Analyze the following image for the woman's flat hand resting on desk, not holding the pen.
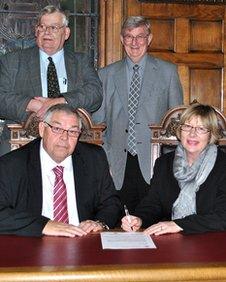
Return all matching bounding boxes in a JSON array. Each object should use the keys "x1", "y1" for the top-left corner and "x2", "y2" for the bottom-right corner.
[{"x1": 144, "y1": 221, "x2": 183, "y2": 236}]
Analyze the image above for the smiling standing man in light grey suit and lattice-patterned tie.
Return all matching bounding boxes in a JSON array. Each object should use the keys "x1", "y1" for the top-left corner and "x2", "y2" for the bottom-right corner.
[{"x1": 93, "y1": 16, "x2": 183, "y2": 212}]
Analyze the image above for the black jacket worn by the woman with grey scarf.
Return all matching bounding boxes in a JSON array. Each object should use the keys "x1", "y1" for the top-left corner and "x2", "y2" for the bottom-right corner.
[{"x1": 135, "y1": 149, "x2": 226, "y2": 233}]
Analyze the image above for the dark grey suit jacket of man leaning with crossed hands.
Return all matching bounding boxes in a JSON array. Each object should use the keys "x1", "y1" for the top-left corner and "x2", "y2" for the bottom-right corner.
[{"x1": 0, "y1": 47, "x2": 102, "y2": 145}]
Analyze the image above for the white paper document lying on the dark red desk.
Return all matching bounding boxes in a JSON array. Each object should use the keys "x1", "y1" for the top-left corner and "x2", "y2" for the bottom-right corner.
[{"x1": 100, "y1": 232, "x2": 156, "y2": 250}]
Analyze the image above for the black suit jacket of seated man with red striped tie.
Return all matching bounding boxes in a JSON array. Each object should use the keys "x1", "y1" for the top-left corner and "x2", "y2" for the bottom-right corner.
[{"x1": 0, "y1": 139, "x2": 121, "y2": 236}]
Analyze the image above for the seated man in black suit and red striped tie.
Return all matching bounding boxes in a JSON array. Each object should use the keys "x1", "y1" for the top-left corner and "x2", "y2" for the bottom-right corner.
[{"x1": 0, "y1": 104, "x2": 121, "y2": 237}]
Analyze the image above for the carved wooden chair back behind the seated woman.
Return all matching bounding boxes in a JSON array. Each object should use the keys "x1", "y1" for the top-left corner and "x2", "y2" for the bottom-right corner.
[{"x1": 149, "y1": 101, "x2": 226, "y2": 175}]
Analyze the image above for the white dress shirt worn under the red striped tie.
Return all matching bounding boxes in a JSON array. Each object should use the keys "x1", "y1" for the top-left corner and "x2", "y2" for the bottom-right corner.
[{"x1": 40, "y1": 141, "x2": 79, "y2": 225}]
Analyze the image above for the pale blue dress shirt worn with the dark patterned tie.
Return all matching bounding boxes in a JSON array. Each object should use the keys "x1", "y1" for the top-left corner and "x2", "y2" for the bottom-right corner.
[{"x1": 39, "y1": 49, "x2": 68, "y2": 97}]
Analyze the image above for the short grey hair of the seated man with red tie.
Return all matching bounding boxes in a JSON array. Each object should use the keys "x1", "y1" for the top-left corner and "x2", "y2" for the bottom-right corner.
[{"x1": 43, "y1": 104, "x2": 82, "y2": 130}]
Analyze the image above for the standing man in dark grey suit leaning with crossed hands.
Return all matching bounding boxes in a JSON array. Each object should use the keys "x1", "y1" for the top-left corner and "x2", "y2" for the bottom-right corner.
[{"x1": 0, "y1": 6, "x2": 102, "y2": 154}]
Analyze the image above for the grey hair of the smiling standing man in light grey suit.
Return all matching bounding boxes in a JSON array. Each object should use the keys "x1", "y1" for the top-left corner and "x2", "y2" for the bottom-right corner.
[{"x1": 121, "y1": 16, "x2": 151, "y2": 35}]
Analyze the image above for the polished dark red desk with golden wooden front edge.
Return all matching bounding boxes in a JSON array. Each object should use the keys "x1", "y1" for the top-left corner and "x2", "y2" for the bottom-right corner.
[{"x1": 0, "y1": 232, "x2": 226, "y2": 282}]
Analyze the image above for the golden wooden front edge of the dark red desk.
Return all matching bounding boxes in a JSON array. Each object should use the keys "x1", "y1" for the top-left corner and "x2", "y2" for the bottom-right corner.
[{"x1": 0, "y1": 263, "x2": 226, "y2": 282}]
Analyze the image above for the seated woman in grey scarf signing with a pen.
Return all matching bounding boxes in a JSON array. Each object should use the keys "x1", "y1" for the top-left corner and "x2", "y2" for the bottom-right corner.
[{"x1": 122, "y1": 104, "x2": 226, "y2": 235}]
